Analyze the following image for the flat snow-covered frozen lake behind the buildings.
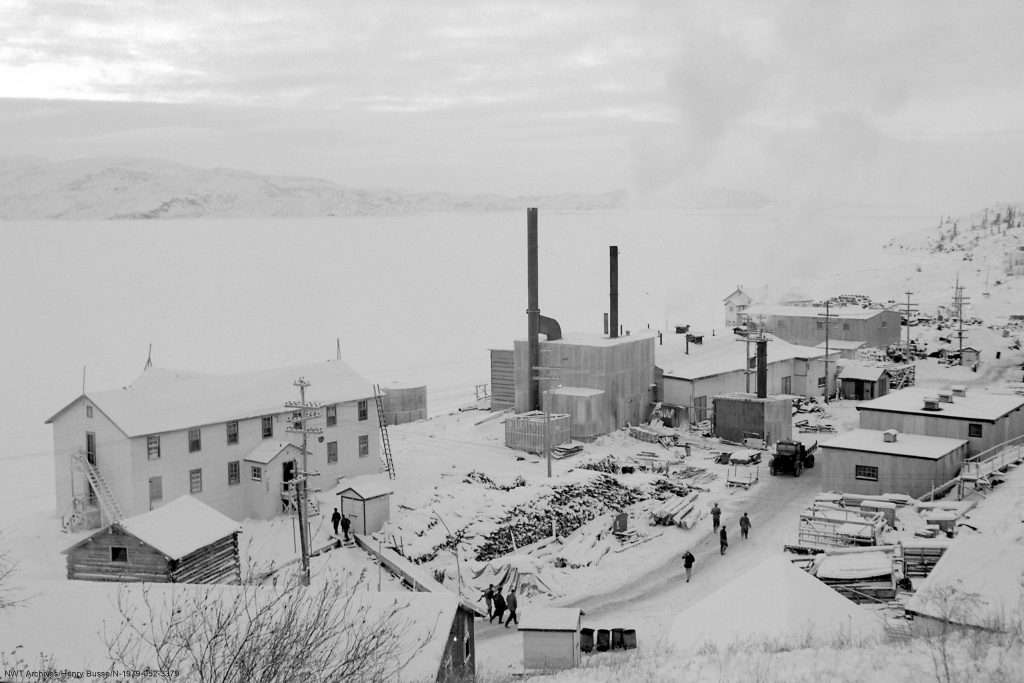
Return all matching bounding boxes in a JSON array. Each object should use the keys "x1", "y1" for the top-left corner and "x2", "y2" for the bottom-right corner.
[{"x1": 0, "y1": 208, "x2": 937, "y2": 457}]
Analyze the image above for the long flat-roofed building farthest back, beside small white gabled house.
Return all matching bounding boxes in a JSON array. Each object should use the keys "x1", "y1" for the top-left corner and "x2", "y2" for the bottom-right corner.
[{"x1": 746, "y1": 305, "x2": 900, "y2": 350}]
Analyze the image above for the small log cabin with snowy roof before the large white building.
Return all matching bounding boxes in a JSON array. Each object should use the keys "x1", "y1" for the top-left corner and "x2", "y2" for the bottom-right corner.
[{"x1": 63, "y1": 496, "x2": 242, "y2": 584}]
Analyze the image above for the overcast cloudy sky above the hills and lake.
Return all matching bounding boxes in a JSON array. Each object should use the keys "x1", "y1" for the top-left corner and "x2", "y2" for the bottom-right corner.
[{"x1": 0, "y1": 0, "x2": 1024, "y2": 211}]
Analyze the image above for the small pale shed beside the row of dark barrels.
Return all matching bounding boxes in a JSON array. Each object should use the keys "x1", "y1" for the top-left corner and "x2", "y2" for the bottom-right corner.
[{"x1": 519, "y1": 607, "x2": 581, "y2": 671}]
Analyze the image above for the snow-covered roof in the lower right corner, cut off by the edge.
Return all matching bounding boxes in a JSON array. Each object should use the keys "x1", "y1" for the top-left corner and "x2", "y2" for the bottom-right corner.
[{"x1": 906, "y1": 525, "x2": 1024, "y2": 628}]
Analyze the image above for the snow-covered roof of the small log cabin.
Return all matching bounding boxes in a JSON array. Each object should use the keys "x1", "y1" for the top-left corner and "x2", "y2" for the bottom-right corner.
[{"x1": 65, "y1": 496, "x2": 242, "y2": 560}]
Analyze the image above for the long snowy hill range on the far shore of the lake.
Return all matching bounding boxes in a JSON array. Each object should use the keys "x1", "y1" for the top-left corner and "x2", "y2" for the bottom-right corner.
[{"x1": 0, "y1": 158, "x2": 769, "y2": 220}]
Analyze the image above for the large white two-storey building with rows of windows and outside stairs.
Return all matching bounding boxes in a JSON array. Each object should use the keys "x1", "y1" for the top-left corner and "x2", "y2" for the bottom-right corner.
[{"x1": 47, "y1": 361, "x2": 381, "y2": 527}]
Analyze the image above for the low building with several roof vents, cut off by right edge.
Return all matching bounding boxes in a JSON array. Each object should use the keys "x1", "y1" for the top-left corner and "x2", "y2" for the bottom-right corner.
[{"x1": 857, "y1": 386, "x2": 1024, "y2": 456}]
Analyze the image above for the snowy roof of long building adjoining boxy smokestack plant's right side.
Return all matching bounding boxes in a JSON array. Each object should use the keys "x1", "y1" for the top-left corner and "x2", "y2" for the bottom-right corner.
[{"x1": 654, "y1": 334, "x2": 825, "y2": 380}]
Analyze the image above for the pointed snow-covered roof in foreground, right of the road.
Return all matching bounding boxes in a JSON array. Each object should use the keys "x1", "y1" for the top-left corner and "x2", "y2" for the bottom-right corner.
[{"x1": 670, "y1": 556, "x2": 885, "y2": 651}]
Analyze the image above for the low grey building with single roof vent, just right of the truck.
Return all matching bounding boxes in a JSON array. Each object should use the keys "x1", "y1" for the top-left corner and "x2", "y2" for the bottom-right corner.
[{"x1": 817, "y1": 429, "x2": 968, "y2": 498}]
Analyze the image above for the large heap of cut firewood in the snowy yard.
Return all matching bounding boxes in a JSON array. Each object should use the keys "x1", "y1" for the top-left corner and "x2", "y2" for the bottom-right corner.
[{"x1": 475, "y1": 475, "x2": 645, "y2": 561}]
